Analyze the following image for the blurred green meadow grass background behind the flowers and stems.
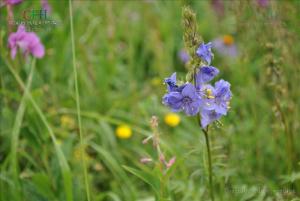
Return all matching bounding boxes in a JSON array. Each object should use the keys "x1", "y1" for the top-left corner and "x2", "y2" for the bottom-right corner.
[{"x1": 0, "y1": 0, "x2": 300, "y2": 201}]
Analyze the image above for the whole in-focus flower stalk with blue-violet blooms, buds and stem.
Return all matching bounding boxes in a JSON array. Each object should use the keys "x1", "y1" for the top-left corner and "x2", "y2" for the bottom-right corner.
[{"x1": 162, "y1": 7, "x2": 232, "y2": 201}]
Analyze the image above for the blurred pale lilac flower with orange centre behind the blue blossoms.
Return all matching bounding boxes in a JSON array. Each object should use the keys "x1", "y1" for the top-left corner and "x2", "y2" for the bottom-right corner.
[{"x1": 212, "y1": 35, "x2": 238, "y2": 57}]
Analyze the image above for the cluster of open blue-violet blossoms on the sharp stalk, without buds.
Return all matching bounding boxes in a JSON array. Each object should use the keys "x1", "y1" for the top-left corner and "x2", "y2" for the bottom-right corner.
[{"x1": 163, "y1": 43, "x2": 232, "y2": 128}]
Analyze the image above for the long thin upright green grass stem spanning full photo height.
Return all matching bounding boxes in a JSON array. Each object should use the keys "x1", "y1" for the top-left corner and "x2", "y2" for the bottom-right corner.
[{"x1": 69, "y1": 0, "x2": 90, "y2": 201}]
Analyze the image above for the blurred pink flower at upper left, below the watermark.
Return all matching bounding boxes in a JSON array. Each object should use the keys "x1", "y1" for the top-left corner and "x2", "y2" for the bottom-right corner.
[{"x1": 8, "y1": 25, "x2": 45, "y2": 59}]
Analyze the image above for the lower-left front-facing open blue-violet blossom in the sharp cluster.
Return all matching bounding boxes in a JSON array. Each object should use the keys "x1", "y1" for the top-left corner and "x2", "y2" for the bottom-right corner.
[{"x1": 163, "y1": 83, "x2": 201, "y2": 116}]
